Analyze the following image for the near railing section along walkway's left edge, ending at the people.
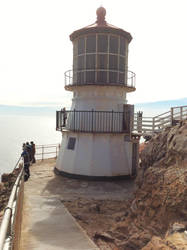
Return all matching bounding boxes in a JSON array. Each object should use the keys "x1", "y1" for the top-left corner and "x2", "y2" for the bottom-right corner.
[{"x1": 0, "y1": 158, "x2": 24, "y2": 250}]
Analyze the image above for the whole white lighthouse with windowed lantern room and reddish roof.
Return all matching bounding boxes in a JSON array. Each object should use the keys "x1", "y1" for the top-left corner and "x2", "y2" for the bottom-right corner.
[{"x1": 55, "y1": 7, "x2": 139, "y2": 180}]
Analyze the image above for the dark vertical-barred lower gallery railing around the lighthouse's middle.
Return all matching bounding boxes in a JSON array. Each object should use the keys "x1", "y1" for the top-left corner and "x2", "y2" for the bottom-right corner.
[{"x1": 56, "y1": 110, "x2": 133, "y2": 133}]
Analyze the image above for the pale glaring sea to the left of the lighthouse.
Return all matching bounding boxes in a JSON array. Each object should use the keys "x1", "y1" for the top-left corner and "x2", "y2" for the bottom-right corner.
[{"x1": 0, "y1": 114, "x2": 61, "y2": 175}]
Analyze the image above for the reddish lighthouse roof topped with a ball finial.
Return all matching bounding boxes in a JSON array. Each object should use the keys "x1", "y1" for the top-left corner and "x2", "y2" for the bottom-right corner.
[{"x1": 70, "y1": 7, "x2": 132, "y2": 43}]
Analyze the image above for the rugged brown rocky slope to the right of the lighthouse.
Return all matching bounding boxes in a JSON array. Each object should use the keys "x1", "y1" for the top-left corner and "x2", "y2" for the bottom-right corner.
[{"x1": 112, "y1": 121, "x2": 187, "y2": 250}]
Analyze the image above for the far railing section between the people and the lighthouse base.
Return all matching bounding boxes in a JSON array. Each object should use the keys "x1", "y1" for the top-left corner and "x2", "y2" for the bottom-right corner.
[{"x1": 35, "y1": 144, "x2": 60, "y2": 160}]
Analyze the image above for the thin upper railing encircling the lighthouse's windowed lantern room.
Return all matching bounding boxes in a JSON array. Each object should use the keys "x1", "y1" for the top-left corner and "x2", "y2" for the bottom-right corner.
[{"x1": 64, "y1": 69, "x2": 136, "y2": 89}]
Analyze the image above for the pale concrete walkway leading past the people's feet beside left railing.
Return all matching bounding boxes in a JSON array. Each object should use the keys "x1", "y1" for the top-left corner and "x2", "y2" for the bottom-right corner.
[{"x1": 20, "y1": 160, "x2": 98, "y2": 250}]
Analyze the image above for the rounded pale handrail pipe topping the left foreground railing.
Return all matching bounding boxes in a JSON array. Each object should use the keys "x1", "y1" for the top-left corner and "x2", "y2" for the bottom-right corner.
[{"x1": 0, "y1": 158, "x2": 24, "y2": 250}]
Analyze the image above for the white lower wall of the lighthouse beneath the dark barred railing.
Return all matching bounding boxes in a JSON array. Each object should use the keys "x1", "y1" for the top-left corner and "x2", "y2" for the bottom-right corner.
[{"x1": 56, "y1": 132, "x2": 132, "y2": 176}]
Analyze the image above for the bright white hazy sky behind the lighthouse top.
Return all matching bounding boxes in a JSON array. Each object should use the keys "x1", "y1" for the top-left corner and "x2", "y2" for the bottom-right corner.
[{"x1": 0, "y1": 0, "x2": 187, "y2": 106}]
